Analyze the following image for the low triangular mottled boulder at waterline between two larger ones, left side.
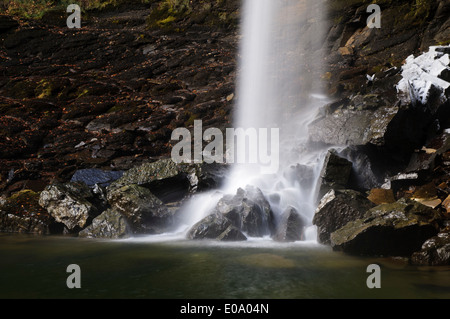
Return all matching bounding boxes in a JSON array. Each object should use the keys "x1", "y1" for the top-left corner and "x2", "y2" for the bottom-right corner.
[{"x1": 78, "y1": 209, "x2": 131, "y2": 239}]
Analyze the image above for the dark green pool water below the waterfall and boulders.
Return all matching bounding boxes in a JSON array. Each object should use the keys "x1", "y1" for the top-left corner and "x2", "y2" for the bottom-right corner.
[{"x1": 0, "y1": 235, "x2": 450, "y2": 299}]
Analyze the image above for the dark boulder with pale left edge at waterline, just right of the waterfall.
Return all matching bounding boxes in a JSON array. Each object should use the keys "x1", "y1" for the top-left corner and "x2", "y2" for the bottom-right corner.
[{"x1": 312, "y1": 190, "x2": 375, "y2": 245}]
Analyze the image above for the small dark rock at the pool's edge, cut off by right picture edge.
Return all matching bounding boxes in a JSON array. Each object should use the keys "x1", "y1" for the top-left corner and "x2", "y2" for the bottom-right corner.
[{"x1": 411, "y1": 231, "x2": 450, "y2": 266}]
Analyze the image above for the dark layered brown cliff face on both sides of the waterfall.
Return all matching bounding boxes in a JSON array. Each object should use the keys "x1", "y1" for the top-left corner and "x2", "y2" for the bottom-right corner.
[{"x1": 0, "y1": 0, "x2": 450, "y2": 255}]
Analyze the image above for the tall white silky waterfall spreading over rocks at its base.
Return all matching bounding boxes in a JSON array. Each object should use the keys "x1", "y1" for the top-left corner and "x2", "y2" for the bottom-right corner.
[{"x1": 179, "y1": 0, "x2": 326, "y2": 239}]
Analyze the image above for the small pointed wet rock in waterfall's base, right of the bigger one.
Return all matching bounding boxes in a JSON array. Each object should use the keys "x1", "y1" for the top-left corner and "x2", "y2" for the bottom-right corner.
[{"x1": 272, "y1": 207, "x2": 306, "y2": 242}]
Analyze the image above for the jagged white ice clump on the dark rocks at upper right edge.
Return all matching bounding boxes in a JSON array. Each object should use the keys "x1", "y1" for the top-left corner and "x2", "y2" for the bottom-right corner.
[{"x1": 397, "y1": 45, "x2": 450, "y2": 104}]
